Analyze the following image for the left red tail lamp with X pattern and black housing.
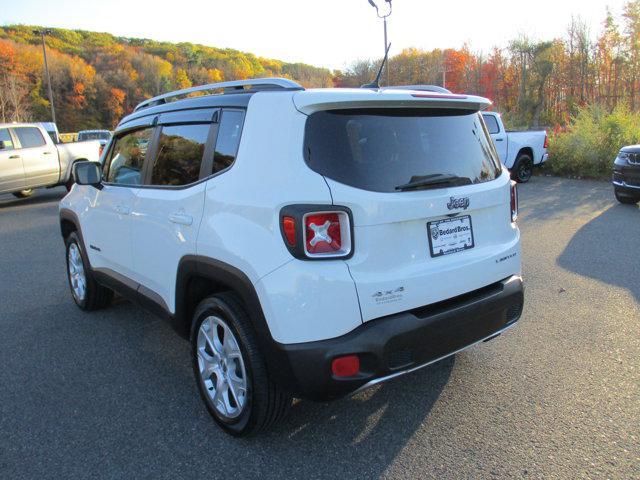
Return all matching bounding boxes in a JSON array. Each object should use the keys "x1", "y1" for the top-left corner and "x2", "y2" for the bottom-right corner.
[{"x1": 280, "y1": 205, "x2": 353, "y2": 260}]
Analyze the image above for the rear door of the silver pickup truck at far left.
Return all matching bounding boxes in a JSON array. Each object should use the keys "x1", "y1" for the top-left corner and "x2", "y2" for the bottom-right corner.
[{"x1": 12, "y1": 127, "x2": 60, "y2": 188}]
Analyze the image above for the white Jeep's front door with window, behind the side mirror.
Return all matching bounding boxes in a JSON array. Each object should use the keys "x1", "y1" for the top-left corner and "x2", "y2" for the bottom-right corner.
[{"x1": 82, "y1": 126, "x2": 154, "y2": 283}]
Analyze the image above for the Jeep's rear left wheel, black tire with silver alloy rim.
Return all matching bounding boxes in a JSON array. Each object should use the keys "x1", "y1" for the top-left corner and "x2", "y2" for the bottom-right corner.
[{"x1": 191, "y1": 293, "x2": 291, "y2": 437}]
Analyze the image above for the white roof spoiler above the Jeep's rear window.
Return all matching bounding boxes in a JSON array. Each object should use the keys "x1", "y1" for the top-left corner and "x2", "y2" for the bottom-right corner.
[{"x1": 293, "y1": 89, "x2": 491, "y2": 115}]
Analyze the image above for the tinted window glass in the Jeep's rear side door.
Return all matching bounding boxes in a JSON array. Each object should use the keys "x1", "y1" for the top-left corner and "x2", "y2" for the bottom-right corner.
[{"x1": 151, "y1": 124, "x2": 210, "y2": 186}]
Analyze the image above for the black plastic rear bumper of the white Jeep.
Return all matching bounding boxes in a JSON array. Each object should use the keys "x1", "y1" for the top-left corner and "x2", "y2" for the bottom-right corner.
[{"x1": 278, "y1": 276, "x2": 524, "y2": 400}]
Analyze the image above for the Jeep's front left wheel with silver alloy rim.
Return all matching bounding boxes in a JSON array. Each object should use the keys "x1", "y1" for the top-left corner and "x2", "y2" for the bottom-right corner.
[{"x1": 65, "y1": 232, "x2": 113, "y2": 311}]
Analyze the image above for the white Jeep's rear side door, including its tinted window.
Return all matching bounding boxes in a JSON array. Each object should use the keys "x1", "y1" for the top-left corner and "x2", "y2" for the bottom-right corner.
[{"x1": 132, "y1": 109, "x2": 217, "y2": 312}]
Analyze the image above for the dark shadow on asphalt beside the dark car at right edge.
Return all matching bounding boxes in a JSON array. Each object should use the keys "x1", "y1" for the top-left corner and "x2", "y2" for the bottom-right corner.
[{"x1": 557, "y1": 204, "x2": 640, "y2": 302}]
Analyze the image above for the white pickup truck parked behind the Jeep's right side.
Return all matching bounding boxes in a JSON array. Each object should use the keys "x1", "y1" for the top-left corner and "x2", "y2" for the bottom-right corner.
[{"x1": 482, "y1": 112, "x2": 549, "y2": 183}]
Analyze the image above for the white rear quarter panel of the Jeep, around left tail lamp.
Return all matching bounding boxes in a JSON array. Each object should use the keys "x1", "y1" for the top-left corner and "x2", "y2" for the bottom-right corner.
[{"x1": 197, "y1": 92, "x2": 362, "y2": 343}]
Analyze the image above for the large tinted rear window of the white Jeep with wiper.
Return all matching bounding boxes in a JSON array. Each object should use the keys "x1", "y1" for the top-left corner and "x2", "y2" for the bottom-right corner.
[{"x1": 305, "y1": 109, "x2": 501, "y2": 192}]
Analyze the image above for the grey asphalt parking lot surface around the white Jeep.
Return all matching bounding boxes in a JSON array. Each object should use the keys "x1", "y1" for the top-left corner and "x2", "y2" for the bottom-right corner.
[{"x1": 0, "y1": 177, "x2": 640, "y2": 479}]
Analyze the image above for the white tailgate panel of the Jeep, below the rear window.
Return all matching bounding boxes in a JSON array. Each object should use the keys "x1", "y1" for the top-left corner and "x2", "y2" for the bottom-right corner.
[{"x1": 328, "y1": 170, "x2": 520, "y2": 321}]
